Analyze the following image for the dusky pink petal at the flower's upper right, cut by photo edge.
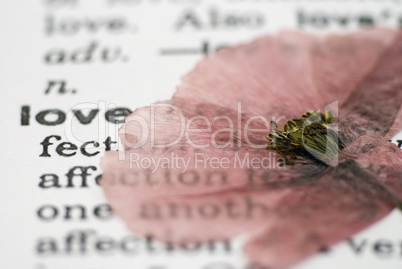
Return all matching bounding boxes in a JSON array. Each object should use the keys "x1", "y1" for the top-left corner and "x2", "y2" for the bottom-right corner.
[{"x1": 338, "y1": 33, "x2": 402, "y2": 144}]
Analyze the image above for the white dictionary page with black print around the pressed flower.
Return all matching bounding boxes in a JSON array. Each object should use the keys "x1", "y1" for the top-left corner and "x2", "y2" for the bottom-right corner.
[{"x1": 0, "y1": 0, "x2": 402, "y2": 269}]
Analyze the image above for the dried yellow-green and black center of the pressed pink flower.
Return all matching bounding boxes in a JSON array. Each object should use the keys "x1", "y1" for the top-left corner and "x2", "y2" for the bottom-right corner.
[{"x1": 267, "y1": 111, "x2": 345, "y2": 165}]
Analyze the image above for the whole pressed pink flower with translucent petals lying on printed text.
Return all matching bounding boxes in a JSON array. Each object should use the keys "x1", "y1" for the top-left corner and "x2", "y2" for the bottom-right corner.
[{"x1": 101, "y1": 29, "x2": 402, "y2": 268}]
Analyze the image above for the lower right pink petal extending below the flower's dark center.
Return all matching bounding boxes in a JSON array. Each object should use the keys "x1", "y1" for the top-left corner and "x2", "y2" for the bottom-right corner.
[{"x1": 245, "y1": 134, "x2": 402, "y2": 268}]
